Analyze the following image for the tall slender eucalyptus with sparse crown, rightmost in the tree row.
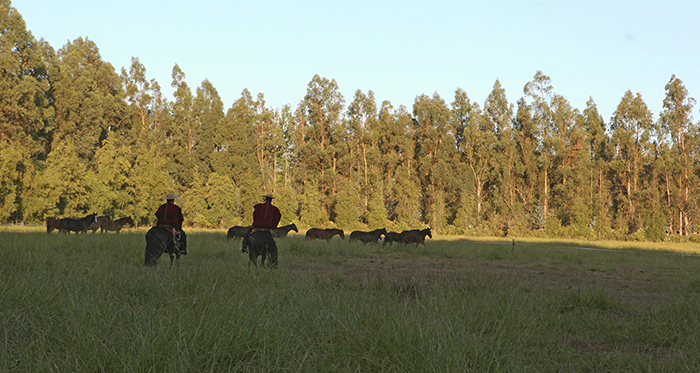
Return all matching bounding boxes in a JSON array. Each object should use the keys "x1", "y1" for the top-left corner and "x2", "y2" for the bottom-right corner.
[{"x1": 659, "y1": 75, "x2": 698, "y2": 235}]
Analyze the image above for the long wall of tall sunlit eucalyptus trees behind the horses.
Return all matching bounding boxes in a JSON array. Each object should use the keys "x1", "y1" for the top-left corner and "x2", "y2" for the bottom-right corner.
[{"x1": 0, "y1": 0, "x2": 700, "y2": 241}]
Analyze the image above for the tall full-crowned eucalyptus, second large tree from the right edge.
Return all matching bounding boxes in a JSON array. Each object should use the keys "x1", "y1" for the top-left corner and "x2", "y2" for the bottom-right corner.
[{"x1": 610, "y1": 90, "x2": 654, "y2": 233}]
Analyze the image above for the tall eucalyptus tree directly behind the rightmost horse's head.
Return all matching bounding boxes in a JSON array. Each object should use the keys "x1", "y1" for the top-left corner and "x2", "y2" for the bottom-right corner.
[{"x1": 413, "y1": 93, "x2": 455, "y2": 232}]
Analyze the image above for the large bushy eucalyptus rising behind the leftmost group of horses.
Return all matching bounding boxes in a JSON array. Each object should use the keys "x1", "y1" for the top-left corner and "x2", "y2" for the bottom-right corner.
[{"x1": 47, "y1": 38, "x2": 126, "y2": 215}]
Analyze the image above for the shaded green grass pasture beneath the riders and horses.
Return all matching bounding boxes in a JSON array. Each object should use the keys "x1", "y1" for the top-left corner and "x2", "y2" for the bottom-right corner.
[{"x1": 0, "y1": 228, "x2": 700, "y2": 372}]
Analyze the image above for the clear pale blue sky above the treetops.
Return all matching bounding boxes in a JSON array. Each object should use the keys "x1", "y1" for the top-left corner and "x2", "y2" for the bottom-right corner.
[{"x1": 12, "y1": 0, "x2": 700, "y2": 121}]
